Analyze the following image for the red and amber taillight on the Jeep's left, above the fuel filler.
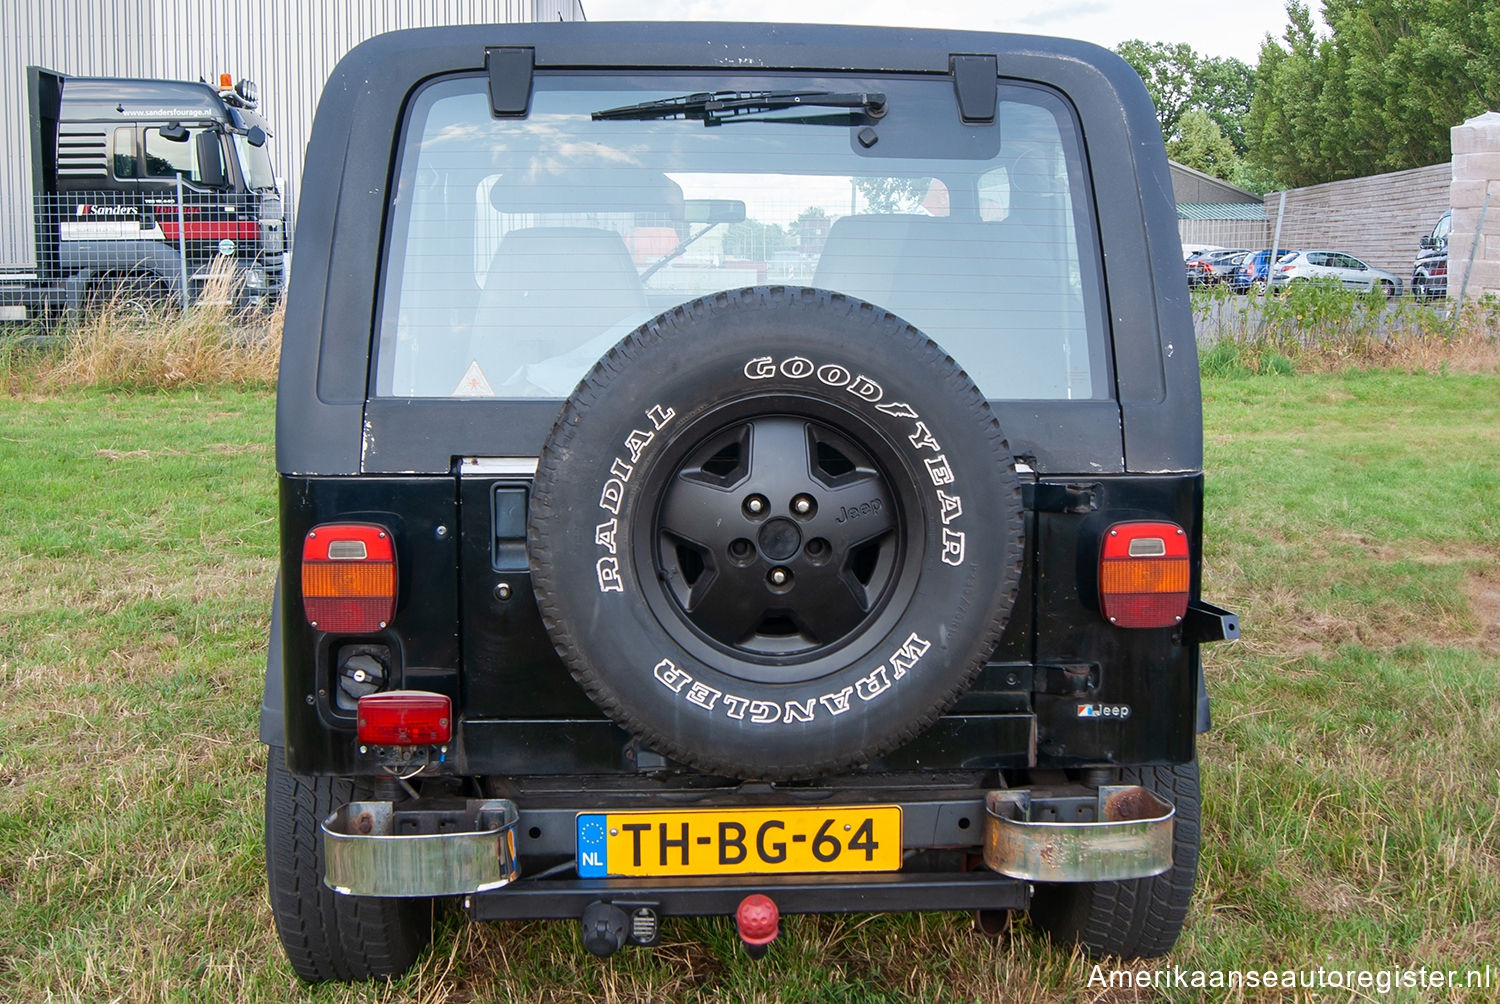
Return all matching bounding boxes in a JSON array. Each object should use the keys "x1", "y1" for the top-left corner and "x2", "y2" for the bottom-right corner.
[{"x1": 302, "y1": 522, "x2": 396, "y2": 635}]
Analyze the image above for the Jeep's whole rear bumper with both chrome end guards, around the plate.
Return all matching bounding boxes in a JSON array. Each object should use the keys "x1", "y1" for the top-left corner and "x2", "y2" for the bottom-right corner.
[{"x1": 323, "y1": 785, "x2": 1175, "y2": 920}]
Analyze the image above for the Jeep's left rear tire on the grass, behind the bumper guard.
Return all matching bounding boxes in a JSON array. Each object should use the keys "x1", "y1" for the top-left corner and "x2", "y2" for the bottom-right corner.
[{"x1": 266, "y1": 746, "x2": 432, "y2": 983}]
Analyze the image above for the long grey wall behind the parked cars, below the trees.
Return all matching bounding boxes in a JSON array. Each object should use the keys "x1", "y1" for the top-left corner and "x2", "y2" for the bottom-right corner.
[{"x1": 1266, "y1": 163, "x2": 1452, "y2": 276}]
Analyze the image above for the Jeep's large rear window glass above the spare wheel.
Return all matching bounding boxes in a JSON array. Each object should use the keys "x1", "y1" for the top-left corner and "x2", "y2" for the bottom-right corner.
[{"x1": 372, "y1": 75, "x2": 1112, "y2": 399}]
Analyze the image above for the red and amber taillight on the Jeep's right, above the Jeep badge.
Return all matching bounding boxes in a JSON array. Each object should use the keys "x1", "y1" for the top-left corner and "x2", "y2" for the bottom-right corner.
[{"x1": 1100, "y1": 521, "x2": 1193, "y2": 627}]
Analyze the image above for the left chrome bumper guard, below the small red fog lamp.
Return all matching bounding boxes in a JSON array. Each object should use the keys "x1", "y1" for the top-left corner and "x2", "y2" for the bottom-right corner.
[{"x1": 323, "y1": 798, "x2": 521, "y2": 896}]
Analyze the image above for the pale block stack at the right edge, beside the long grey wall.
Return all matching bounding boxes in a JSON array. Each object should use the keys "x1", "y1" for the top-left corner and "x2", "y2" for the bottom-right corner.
[{"x1": 1448, "y1": 111, "x2": 1500, "y2": 297}]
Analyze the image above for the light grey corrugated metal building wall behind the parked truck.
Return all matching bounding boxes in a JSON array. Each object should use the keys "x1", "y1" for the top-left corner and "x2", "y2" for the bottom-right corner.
[{"x1": 0, "y1": 0, "x2": 584, "y2": 266}]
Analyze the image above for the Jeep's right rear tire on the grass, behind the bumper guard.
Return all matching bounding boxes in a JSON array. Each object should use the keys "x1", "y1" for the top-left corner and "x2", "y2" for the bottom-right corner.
[{"x1": 1031, "y1": 761, "x2": 1200, "y2": 959}]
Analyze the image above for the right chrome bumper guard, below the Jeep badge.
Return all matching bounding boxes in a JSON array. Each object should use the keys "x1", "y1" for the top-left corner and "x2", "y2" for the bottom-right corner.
[{"x1": 984, "y1": 785, "x2": 1176, "y2": 882}]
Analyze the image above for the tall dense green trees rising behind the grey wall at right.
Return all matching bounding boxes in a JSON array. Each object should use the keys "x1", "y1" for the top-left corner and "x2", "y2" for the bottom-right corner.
[{"x1": 1245, "y1": 0, "x2": 1500, "y2": 186}]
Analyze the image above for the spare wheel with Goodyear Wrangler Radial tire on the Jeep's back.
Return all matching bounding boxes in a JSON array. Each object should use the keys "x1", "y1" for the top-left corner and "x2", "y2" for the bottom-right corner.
[{"x1": 528, "y1": 287, "x2": 1022, "y2": 779}]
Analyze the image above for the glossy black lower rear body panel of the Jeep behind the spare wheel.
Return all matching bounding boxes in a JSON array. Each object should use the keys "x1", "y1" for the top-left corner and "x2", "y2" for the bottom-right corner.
[{"x1": 281, "y1": 476, "x2": 1202, "y2": 774}]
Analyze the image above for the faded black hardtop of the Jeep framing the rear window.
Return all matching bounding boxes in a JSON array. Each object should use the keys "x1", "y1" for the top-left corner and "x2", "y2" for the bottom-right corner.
[{"x1": 276, "y1": 23, "x2": 1203, "y2": 476}]
